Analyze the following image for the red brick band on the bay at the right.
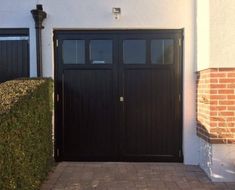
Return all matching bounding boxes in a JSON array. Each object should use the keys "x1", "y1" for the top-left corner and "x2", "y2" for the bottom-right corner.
[{"x1": 197, "y1": 68, "x2": 235, "y2": 144}]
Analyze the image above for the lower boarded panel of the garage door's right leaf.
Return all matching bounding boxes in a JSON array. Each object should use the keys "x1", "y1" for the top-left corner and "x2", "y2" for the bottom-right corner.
[{"x1": 123, "y1": 69, "x2": 175, "y2": 157}]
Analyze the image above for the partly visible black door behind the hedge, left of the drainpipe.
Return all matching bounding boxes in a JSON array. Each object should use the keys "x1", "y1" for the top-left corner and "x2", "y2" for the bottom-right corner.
[{"x1": 0, "y1": 29, "x2": 29, "y2": 83}]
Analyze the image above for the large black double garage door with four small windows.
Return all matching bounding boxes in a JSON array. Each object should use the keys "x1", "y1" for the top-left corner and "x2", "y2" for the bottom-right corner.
[{"x1": 55, "y1": 30, "x2": 182, "y2": 162}]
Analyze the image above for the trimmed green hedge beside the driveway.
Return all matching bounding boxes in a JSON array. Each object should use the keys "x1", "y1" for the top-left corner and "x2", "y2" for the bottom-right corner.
[{"x1": 0, "y1": 79, "x2": 53, "y2": 190}]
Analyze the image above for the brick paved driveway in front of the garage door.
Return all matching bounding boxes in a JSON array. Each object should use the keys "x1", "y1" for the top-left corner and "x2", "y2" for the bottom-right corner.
[{"x1": 41, "y1": 162, "x2": 235, "y2": 190}]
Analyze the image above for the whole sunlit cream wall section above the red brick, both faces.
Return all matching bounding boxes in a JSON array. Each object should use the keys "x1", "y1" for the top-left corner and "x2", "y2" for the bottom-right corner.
[{"x1": 196, "y1": 0, "x2": 235, "y2": 71}]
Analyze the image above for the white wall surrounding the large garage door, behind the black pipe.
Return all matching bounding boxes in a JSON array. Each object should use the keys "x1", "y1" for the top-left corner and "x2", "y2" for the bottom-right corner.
[{"x1": 0, "y1": 0, "x2": 199, "y2": 164}]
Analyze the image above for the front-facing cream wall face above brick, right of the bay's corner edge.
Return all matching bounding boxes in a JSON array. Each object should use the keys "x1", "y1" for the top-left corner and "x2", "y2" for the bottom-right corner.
[{"x1": 210, "y1": 0, "x2": 235, "y2": 68}]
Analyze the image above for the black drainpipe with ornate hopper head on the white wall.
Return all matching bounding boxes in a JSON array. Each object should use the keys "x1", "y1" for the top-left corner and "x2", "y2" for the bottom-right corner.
[{"x1": 31, "y1": 5, "x2": 47, "y2": 77}]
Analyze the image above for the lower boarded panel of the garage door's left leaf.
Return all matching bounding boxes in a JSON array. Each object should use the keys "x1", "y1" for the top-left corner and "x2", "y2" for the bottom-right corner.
[{"x1": 64, "y1": 70, "x2": 114, "y2": 157}]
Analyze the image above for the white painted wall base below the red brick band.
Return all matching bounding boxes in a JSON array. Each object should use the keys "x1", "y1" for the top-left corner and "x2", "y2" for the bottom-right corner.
[{"x1": 200, "y1": 139, "x2": 235, "y2": 182}]
